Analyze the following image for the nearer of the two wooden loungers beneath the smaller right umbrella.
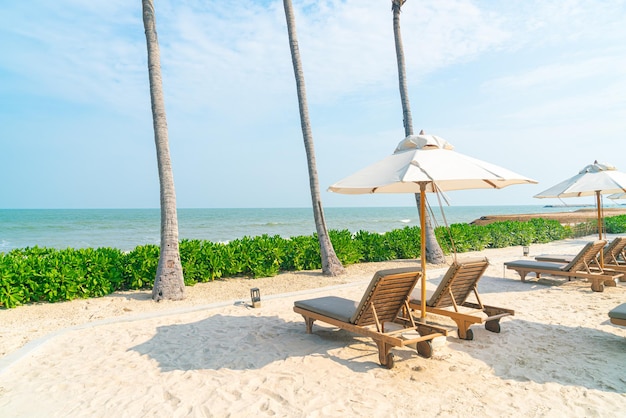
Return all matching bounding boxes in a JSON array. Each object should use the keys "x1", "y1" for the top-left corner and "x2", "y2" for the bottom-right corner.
[{"x1": 504, "y1": 240, "x2": 624, "y2": 292}]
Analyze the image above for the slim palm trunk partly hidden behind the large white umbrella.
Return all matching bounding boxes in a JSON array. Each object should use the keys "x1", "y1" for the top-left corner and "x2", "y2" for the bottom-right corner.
[{"x1": 391, "y1": 0, "x2": 446, "y2": 264}]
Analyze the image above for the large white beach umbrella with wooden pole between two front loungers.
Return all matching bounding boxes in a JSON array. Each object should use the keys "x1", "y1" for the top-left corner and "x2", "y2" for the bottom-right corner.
[{"x1": 328, "y1": 133, "x2": 537, "y2": 318}]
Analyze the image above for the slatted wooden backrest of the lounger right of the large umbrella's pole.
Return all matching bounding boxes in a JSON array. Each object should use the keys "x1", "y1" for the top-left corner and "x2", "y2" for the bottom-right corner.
[{"x1": 427, "y1": 257, "x2": 489, "y2": 308}]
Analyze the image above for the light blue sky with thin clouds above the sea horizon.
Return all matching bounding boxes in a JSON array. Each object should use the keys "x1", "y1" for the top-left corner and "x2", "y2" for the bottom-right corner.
[{"x1": 0, "y1": 0, "x2": 626, "y2": 208}]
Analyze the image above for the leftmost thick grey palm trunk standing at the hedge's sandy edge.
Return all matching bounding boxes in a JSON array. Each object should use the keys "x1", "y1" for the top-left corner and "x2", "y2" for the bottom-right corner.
[{"x1": 142, "y1": 0, "x2": 185, "y2": 302}]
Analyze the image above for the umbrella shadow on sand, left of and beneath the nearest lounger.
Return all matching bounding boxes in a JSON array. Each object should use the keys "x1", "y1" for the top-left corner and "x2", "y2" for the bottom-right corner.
[{"x1": 130, "y1": 314, "x2": 392, "y2": 372}]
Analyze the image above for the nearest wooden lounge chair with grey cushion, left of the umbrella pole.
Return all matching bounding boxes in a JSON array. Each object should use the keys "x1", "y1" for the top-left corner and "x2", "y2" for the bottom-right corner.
[{"x1": 293, "y1": 268, "x2": 447, "y2": 369}]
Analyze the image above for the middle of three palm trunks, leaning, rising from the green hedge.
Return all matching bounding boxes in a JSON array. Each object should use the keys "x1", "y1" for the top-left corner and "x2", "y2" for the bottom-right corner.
[{"x1": 283, "y1": 0, "x2": 345, "y2": 276}]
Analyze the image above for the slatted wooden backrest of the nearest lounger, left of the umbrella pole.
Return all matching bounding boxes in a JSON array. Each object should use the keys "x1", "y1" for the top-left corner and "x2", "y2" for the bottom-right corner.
[{"x1": 350, "y1": 267, "x2": 422, "y2": 326}]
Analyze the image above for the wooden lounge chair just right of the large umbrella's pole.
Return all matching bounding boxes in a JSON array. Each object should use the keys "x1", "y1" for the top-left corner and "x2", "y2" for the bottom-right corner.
[{"x1": 409, "y1": 257, "x2": 515, "y2": 340}]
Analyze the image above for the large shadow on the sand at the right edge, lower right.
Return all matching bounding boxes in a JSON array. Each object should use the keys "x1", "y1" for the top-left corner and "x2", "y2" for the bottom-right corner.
[{"x1": 450, "y1": 318, "x2": 626, "y2": 393}]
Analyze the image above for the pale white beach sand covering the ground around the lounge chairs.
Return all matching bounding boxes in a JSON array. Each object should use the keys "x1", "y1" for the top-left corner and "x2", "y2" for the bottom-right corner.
[{"x1": 0, "y1": 237, "x2": 626, "y2": 417}]
